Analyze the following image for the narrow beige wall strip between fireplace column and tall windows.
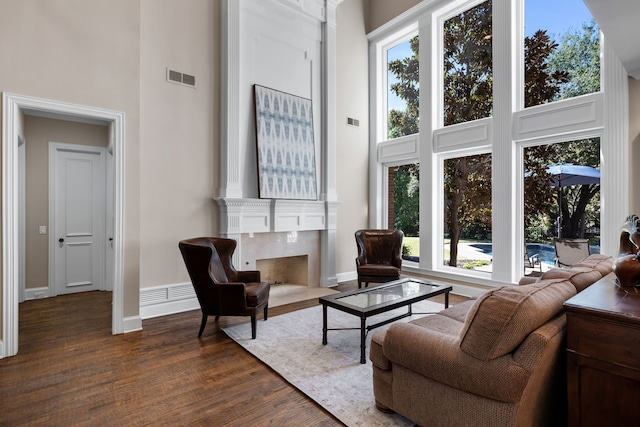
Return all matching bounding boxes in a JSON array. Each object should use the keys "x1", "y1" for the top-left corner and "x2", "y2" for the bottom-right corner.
[{"x1": 336, "y1": 0, "x2": 369, "y2": 273}]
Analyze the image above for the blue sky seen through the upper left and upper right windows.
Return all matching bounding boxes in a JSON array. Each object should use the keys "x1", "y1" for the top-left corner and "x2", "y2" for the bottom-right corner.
[{"x1": 387, "y1": 0, "x2": 591, "y2": 110}]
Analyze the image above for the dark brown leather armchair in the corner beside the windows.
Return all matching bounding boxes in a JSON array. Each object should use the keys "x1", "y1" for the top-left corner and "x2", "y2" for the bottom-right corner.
[{"x1": 356, "y1": 230, "x2": 404, "y2": 288}]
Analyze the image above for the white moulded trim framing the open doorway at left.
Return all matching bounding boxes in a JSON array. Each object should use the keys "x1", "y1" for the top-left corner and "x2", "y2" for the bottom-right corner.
[{"x1": 0, "y1": 93, "x2": 126, "y2": 358}]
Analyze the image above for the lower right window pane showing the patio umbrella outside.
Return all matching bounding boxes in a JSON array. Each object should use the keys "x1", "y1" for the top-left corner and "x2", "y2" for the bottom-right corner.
[{"x1": 524, "y1": 138, "x2": 600, "y2": 273}]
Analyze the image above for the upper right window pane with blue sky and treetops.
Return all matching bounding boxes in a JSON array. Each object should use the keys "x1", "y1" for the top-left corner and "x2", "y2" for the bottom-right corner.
[{"x1": 524, "y1": 0, "x2": 600, "y2": 107}]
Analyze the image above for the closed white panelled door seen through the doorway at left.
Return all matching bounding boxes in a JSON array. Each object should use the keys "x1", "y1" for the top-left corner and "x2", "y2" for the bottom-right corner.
[{"x1": 49, "y1": 143, "x2": 106, "y2": 295}]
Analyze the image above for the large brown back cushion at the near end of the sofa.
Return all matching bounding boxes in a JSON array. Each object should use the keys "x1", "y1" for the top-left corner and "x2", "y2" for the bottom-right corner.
[{"x1": 460, "y1": 280, "x2": 576, "y2": 360}]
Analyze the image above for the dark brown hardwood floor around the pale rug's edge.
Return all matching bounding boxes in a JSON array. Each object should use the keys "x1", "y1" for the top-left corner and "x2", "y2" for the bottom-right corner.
[{"x1": 0, "y1": 282, "x2": 465, "y2": 426}]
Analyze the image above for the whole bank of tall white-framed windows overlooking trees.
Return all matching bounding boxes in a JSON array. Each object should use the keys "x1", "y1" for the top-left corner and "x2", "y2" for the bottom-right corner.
[{"x1": 370, "y1": 0, "x2": 616, "y2": 282}]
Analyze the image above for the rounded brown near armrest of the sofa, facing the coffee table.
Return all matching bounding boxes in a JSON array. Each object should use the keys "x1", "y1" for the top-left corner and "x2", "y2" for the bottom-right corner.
[{"x1": 383, "y1": 323, "x2": 531, "y2": 402}]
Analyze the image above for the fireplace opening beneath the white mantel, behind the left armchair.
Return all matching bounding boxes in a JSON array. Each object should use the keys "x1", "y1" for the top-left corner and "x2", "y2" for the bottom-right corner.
[{"x1": 256, "y1": 255, "x2": 309, "y2": 286}]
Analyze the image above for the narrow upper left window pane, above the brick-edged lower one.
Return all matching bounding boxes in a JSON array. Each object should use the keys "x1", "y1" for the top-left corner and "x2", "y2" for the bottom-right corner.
[{"x1": 387, "y1": 36, "x2": 420, "y2": 139}]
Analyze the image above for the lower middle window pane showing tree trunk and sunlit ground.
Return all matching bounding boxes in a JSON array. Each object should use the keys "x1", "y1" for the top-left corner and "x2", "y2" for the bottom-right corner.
[{"x1": 444, "y1": 154, "x2": 492, "y2": 271}]
